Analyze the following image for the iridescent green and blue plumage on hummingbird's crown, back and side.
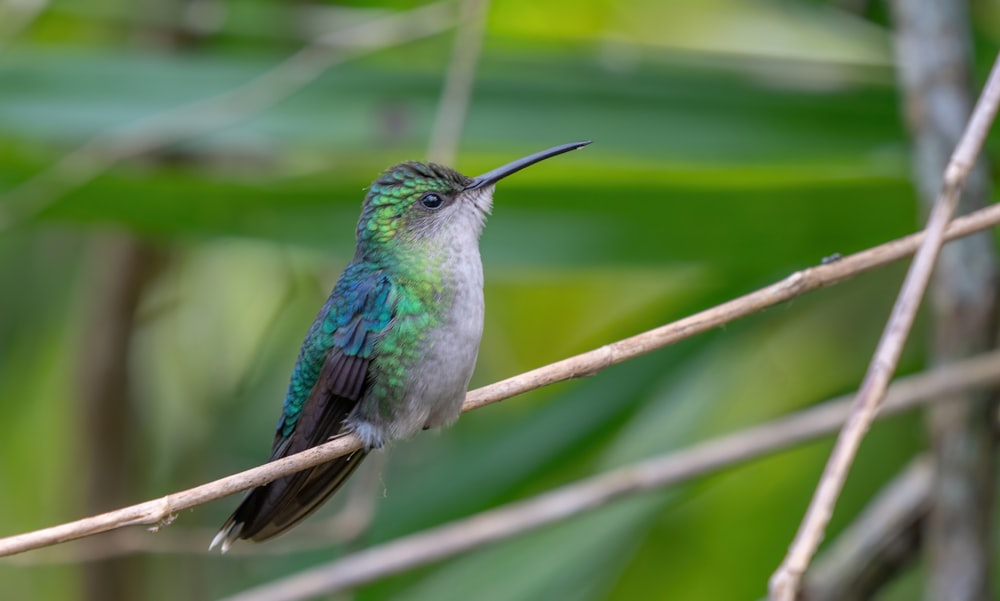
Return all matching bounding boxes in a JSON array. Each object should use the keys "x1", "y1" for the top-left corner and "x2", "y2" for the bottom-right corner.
[{"x1": 275, "y1": 163, "x2": 469, "y2": 446}]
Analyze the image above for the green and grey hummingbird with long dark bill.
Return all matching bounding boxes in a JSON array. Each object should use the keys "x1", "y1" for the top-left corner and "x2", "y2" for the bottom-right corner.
[{"x1": 209, "y1": 141, "x2": 590, "y2": 553}]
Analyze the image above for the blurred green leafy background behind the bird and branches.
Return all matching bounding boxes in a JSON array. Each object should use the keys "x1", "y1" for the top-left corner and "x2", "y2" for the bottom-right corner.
[{"x1": 0, "y1": 0, "x2": 1000, "y2": 600}]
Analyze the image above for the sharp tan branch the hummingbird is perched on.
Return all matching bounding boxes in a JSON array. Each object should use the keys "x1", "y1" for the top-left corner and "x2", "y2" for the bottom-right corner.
[{"x1": 0, "y1": 198, "x2": 1000, "y2": 557}]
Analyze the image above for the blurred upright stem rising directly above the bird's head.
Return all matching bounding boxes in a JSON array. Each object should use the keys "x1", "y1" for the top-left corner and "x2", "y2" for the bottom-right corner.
[{"x1": 427, "y1": 0, "x2": 490, "y2": 165}]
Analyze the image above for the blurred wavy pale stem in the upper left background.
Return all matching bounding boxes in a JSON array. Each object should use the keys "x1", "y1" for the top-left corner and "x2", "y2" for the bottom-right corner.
[{"x1": 0, "y1": 0, "x2": 456, "y2": 231}]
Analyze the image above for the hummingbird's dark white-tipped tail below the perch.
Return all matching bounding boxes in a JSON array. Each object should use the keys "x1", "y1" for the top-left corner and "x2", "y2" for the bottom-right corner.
[{"x1": 208, "y1": 451, "x2": 368, "y2": 553}]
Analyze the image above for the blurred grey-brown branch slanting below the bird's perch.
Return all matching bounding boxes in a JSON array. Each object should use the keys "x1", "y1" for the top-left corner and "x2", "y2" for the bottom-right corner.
[{"x1": 224, "y1": 352, "x2": 1000, "y2": 601}]
